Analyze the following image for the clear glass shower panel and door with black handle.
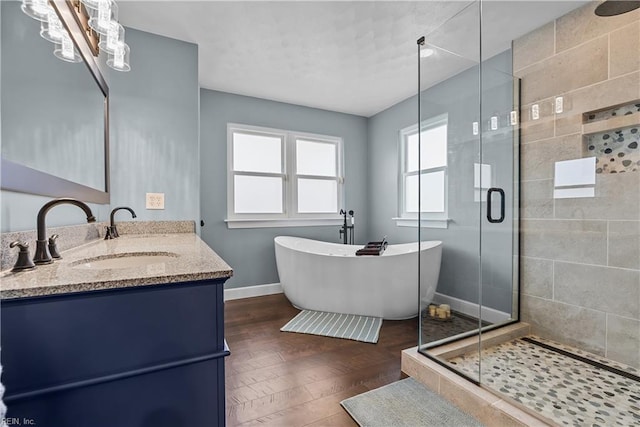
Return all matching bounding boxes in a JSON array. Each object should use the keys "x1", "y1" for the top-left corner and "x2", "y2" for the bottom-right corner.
[{"x1": 417, "y1": 1, "x2": 520, "y2": 383}]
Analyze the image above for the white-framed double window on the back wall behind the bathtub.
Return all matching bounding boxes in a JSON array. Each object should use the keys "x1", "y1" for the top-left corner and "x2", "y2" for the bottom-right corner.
[{"x1": 227, "y1": 124, "x2": 343, "y2": 228}]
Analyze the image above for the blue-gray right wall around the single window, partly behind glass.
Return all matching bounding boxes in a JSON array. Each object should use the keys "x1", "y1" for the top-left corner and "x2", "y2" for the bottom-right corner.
[{"x1": 368, "y1": 52, "x2": 513, "y2": 312}]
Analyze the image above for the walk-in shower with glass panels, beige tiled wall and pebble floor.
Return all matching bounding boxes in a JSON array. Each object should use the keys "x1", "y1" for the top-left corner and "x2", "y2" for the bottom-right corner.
[{"x1": 414, "y1": 0, "x2": 640, "y2": 425}]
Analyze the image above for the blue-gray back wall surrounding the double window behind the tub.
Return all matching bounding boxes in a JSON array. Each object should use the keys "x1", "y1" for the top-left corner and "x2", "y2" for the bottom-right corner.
[{"x1": 200, "y1": 89, "x2": 369, "y2": 287}]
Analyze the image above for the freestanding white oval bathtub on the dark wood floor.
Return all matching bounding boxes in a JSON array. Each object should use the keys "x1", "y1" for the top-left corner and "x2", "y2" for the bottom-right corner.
[{"x1": 274, "y1": 236, "x2": 442, "y2": 320}]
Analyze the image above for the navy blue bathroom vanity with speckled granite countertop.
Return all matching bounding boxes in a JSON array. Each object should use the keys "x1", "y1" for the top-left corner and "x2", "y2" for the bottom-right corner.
[{"x1": 0, "y1": 234, "x2": 233, "y2": 427}]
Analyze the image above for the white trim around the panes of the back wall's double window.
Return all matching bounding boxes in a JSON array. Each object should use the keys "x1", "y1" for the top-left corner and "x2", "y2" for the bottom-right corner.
[{"x1": 224, "y1": 123, "x2": 344, "y2": 228}]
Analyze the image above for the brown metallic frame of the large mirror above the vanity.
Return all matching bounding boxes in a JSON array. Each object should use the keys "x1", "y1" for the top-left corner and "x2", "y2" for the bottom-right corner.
[{"x1": 0, "y1": 0, "x2": 110, "y2": 204}]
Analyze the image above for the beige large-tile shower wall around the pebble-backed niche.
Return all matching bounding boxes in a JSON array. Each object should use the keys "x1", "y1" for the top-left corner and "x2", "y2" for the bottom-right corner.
[{"x1": 513, "y1": 2, "x2": 640, "y2": 368}]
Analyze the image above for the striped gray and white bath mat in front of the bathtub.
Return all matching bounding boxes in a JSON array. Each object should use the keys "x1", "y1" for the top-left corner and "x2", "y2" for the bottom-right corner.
[{"x1": 280, "y1": 310, "x2": 382, "y2": 344}]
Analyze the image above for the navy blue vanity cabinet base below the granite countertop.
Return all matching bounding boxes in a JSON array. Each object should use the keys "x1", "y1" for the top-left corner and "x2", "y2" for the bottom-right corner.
[{"x1": 0, "y1": 278, "x2": 229, "y2": 427}]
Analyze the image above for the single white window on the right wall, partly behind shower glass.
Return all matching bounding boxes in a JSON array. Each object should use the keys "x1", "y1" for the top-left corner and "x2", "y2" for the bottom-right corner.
[{"x1": 397, "y1": 114, "x2": 447, "y2": 227}]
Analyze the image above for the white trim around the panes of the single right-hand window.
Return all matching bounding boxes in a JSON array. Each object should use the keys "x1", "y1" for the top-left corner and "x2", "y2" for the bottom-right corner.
[{"x1": 392, "y1": 113, "x2": 451, "y2": 228}]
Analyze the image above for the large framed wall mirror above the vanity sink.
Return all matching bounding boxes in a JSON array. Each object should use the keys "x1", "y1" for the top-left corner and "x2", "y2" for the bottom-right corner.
[{"x1": 0, "y1": 0, "x2": 109, "y2": 204}]
